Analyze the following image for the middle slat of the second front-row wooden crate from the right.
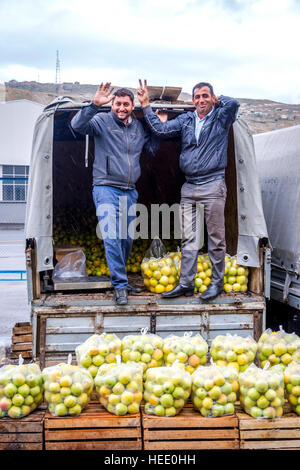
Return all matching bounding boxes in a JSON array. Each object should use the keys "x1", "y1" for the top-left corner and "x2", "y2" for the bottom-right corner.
[{"x1": 144, "y1": 428, "x2": 239, "y2": 441}]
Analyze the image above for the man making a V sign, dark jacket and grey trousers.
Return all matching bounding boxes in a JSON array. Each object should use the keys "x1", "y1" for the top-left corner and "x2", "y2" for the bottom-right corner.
[{"x1": 137, "y1": 81, "x2": 239, "y2": 300}]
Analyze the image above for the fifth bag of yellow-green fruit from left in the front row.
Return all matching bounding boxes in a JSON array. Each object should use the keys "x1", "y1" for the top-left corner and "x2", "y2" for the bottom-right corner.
[{"x1": 192, "y1": 364, "x2": 239, "y2": 417}]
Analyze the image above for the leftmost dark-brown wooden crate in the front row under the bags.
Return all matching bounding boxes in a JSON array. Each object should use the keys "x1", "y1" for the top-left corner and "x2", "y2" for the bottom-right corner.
[{"x1": 0, "y1": 405, "x2": 46, "y2": 450}]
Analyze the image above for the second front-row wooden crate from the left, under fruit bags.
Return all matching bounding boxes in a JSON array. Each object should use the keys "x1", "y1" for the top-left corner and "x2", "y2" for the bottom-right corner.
[{"x1": 45, "y1": 402, "x2": 142, "y2": 450}]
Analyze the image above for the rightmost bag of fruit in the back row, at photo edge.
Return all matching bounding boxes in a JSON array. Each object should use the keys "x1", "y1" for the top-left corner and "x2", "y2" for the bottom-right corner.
[{"x1": 257, "y1": 326, "x2": 300, "y2": 367}]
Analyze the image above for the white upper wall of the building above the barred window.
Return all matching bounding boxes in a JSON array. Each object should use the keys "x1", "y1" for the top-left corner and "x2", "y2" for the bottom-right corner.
[{"x1": 0, "y1": 100, "x2": 44, "y2": 165}]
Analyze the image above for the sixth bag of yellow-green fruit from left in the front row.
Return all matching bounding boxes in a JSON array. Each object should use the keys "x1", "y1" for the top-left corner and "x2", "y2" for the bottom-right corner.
[{"x1": 239, "y1": 364, "x2": 285, "y2": 418}]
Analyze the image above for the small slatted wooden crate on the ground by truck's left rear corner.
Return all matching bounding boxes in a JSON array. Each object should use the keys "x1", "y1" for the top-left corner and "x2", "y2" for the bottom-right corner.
[{"x1": 10, "y1": 322, "x2": 33, "y2": 359}]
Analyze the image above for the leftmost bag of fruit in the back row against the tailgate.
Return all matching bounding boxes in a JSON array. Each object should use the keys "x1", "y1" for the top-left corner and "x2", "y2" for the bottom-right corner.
[{"x1": 75, "y1": 333, "x2": 121, "y2": 378}]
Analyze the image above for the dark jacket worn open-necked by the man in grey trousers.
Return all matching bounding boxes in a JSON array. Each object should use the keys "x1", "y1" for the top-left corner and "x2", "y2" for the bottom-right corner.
[{"x1": 143, "y1": 95, "x2": 239, "y2": 184}]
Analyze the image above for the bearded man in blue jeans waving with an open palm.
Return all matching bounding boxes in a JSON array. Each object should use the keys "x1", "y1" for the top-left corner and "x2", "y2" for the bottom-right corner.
[{"x1": 71, "y1": 83, "x2": 159, "y2": 305}]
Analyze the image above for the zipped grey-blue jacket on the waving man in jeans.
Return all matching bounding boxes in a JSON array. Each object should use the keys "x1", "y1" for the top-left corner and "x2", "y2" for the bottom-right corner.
[{"x1": 71, "y1": 103, "x2": 159, "y2": 190}]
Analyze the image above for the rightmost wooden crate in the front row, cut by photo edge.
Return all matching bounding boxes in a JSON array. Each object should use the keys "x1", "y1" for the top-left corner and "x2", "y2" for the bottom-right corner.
[{"x1": 237, "y1": 412, "x2": 300, "y2": 450}]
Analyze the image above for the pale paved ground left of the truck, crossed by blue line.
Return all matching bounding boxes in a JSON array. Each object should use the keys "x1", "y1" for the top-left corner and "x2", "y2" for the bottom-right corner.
[{"x1": 0, "y1": 228, "x2": 30, "y2": 347}]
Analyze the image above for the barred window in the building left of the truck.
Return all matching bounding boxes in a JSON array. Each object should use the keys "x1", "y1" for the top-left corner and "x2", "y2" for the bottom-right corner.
[{"x1": 2, "y1": 165, "x2": 29, "y2": 202}]
